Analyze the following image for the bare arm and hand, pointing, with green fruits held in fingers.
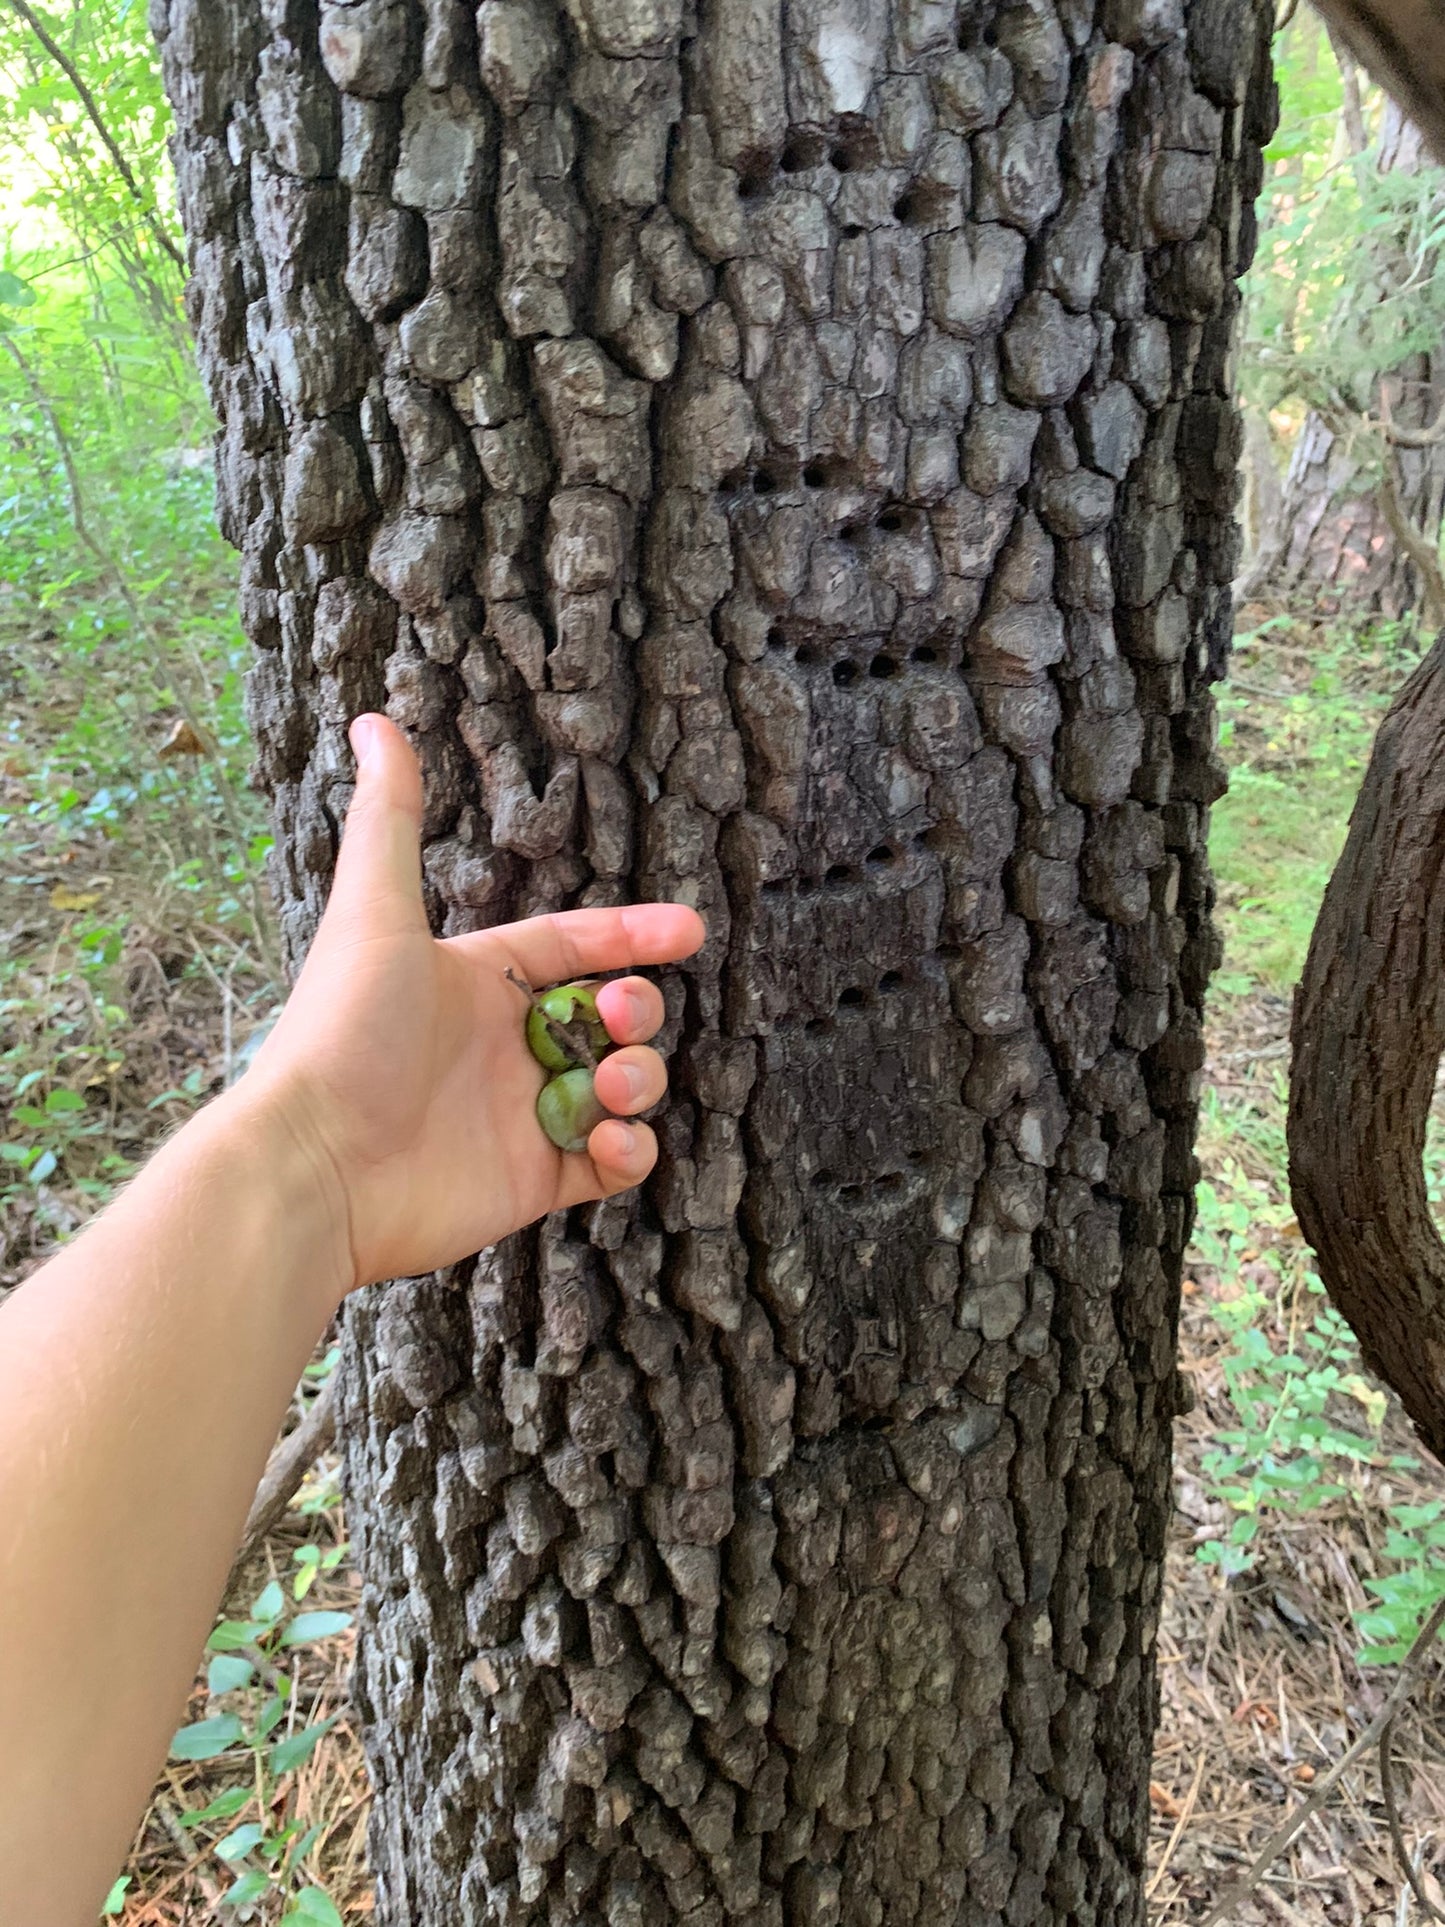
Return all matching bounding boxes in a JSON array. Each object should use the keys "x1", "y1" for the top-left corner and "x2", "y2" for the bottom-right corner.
[{"x1": 0, "y1": 717, "x2": 703, "y2": 1927}]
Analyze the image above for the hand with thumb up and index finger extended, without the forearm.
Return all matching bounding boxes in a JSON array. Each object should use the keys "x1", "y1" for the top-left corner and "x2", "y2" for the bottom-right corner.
[{"x1": 235, "y1": 715, "x2": 705, "y2": 1297}]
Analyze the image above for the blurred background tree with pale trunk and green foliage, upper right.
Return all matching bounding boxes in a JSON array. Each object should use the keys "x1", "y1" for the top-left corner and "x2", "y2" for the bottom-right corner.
[{"x1": 1239, "y1": 12, "x2": 1445, "y2": 622}]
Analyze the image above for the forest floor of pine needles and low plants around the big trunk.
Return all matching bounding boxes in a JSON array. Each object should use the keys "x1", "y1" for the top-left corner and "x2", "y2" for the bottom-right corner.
[{"x1": 0, "y1": 601, "x2": 1445, "y2": 1927}]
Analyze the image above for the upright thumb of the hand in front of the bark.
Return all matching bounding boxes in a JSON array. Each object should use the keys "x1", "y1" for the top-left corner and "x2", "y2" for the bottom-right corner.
[{"x1": 326, "y1": 715, "x2": 426, "y2": 929}]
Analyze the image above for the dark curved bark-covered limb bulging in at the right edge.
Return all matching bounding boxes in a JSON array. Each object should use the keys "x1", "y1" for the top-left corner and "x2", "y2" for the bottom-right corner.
[{"x1": 1289, "y1": 638, "x2": 1445, "y2": 1453}]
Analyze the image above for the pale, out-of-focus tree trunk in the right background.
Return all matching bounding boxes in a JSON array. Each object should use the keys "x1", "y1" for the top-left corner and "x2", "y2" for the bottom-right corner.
[{"x1": 1239, "y1": 101, "x2": 1445, "y2": 619}]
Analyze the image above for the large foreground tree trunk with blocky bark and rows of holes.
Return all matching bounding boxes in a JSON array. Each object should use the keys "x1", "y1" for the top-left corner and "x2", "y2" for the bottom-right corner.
[{"x1": 156, "y1": 0, "x2": 1274, "y2": 1927}]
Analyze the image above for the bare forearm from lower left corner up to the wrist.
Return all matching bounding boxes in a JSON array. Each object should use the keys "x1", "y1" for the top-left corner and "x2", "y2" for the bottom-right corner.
[{"x1": 0, "y1": 1087, "x2": 347, "y2": 1927}]
